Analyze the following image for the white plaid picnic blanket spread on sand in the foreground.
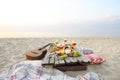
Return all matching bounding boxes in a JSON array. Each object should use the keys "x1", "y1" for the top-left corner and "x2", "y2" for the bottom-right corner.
[{"x1": 0, "y1": 60, "x2": 101, "y2": 80}]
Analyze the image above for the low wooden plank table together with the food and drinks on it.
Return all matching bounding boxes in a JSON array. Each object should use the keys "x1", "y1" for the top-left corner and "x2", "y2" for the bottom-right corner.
[{"x1": 42, "y1": 43, "x2": 90, "y2": 71}]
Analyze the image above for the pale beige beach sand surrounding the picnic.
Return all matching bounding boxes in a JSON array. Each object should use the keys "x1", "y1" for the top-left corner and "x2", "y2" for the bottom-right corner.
[{"x1": 0, "y1": 38, "x2": 120, "y2": 80}]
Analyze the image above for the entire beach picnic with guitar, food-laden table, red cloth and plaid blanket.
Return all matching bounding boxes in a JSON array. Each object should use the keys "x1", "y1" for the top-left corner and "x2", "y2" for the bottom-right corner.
[{"x1": 0, "y1": 39, "x2": 105, "y2": 80}]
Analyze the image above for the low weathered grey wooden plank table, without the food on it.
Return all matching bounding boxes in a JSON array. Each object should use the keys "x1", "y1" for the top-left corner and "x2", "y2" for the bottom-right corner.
[{"x1": 42, "y1": 44, "x2": 89, "y2": 71}]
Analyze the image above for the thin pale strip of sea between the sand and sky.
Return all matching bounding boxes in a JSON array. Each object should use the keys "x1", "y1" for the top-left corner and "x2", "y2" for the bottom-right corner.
[{"x1": 0, "y1": 32, "x2": 120, "y2": 38}]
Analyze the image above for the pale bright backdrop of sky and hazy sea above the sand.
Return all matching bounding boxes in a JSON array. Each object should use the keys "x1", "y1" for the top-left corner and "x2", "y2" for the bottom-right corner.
[{"x1": 0, "y1": 0, "x2": 120, "y2": 37}]
